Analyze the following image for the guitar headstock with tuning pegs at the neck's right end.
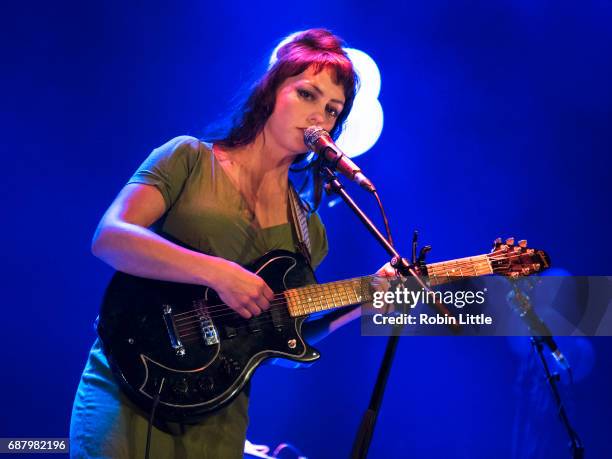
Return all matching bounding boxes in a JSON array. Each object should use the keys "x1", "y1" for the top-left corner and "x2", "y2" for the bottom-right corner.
[{"x1": 488, "y1": 238, "x2": 550, "y2": 277}]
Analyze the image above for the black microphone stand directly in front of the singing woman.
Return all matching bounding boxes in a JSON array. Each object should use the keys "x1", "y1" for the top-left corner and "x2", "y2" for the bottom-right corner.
[{"x1": 321, "y1": 165, "x2": 448, "y2": 459}]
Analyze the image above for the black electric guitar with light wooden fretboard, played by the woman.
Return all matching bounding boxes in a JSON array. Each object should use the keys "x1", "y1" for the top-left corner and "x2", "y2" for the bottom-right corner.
[{"x1": 98, "y1": 241, "x2": 550, "y2": 423}]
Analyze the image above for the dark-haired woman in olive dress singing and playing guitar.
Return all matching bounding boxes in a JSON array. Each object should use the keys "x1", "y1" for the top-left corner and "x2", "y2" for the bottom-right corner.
[{"x1": 70, "y1": 29, "x2": 388, "y2": 458}]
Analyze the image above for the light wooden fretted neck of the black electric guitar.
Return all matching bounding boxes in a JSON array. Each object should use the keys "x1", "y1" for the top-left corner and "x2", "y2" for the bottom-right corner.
[{"x1": 284, "y1": 255, "x2": 493, "y2": 317}]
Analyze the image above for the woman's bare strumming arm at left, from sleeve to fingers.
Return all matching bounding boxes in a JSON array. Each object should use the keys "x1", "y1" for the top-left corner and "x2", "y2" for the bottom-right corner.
[{"x1": 92, "y1": 183, "x2": 274, "y2": 318}]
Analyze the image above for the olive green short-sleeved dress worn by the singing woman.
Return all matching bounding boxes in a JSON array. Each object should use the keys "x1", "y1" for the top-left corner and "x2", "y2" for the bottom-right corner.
[{"x1": 70, "y1": 136, "x2": 327, "y2": 459}]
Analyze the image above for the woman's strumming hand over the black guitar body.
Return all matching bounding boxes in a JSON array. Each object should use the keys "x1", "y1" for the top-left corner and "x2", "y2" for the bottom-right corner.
[{"x1": 211, "y1": 258, "x2": 274, "y2": 319}]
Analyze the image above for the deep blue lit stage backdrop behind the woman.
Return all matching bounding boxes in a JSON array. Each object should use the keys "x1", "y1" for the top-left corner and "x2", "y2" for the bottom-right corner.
[{"x1": 0, "y1": 0, "x2": 612, "y2": 458}]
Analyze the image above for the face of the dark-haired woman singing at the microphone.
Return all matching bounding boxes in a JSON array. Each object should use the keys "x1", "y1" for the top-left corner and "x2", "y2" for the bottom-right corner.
[{"x1": 264, "y1": 67, "x2": 344, "y2": 156}]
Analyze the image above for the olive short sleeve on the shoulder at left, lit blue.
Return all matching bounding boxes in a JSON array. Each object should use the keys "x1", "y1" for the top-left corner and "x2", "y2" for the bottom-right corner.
[{"x1": 128, "y1": 135, "x2": 200, "y2": 209}]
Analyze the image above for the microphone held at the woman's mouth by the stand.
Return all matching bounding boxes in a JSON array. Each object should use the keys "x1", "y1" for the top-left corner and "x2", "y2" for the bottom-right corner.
[{"x1": 304, "y1": 126, "x2": 376, "y2": 193}]
